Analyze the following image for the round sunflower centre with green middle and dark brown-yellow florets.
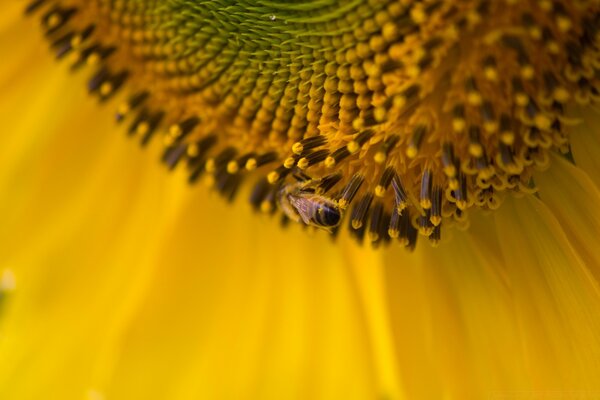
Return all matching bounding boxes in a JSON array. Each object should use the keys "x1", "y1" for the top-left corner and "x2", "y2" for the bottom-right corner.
[{"x1": 28, "y1": 0, "x2": 600, "y2": 247}]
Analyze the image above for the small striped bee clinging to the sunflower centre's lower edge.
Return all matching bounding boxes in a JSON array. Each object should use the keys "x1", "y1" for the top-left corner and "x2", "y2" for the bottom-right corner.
[{"x1": 277, "y1": 179, "x2": 342, "y2": 231}]
